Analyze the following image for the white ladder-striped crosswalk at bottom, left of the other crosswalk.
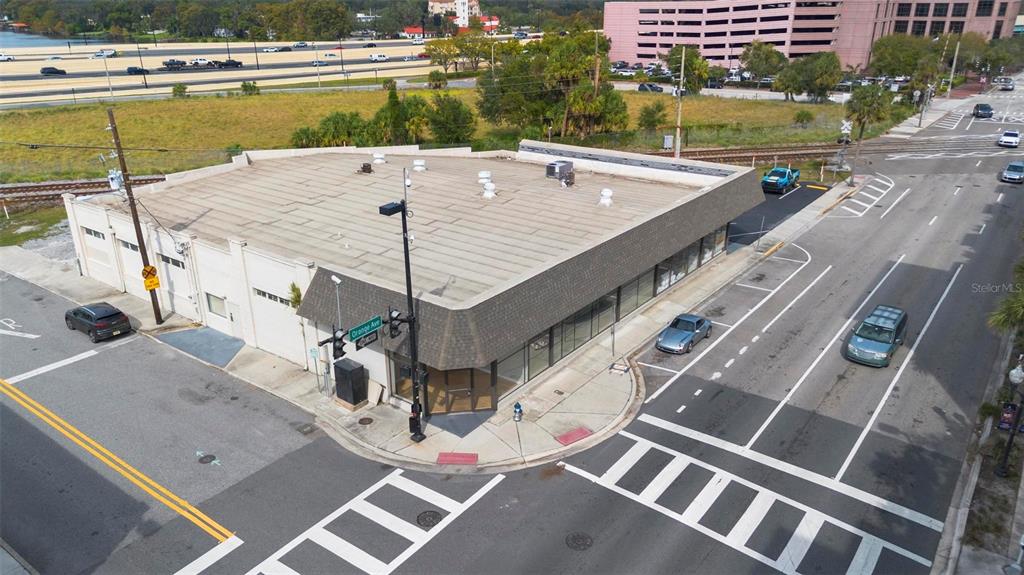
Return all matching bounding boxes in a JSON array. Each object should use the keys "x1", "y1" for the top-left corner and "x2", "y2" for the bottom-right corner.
[{"x1": 247, "y1": 470, "x2": 505, "y2": 575}]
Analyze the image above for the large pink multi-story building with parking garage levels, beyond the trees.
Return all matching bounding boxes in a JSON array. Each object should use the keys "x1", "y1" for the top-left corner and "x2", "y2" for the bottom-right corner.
[{"x1": 604, "y1": 0, "x2": 1020, "y2": 68}]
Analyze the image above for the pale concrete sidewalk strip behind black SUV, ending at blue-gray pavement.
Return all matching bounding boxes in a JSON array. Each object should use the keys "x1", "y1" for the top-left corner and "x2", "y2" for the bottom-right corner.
[{"x1": 0, "y1": 246, "x2": 193, "y2": 334}]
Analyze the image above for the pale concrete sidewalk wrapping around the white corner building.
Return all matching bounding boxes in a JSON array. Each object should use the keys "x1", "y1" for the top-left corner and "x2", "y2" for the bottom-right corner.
[{"x1": 0, "y1": 184, "x2": 850, "y2": 473}]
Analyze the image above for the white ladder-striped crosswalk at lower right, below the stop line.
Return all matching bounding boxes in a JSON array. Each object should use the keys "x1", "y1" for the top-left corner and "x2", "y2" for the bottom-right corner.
[{"x1": 560, "y1": 431, "x2": 932, "y2": 575}]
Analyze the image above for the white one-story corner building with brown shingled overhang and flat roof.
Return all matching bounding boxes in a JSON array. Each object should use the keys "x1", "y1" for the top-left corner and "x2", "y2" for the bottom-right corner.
[{"x1": 66, "y1": 140, "x2": 763, "y2": 412}]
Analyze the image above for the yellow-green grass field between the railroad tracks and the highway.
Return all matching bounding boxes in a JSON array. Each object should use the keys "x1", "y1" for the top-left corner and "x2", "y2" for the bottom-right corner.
[{"x1": 0, "y1": 89, "x2": 877, "y2": 182}]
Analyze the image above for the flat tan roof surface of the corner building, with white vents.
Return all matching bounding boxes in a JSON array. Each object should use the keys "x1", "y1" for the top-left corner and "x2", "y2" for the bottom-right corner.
[{"x1": 93, "y1": 146, "x2": 720, "y2": 307}]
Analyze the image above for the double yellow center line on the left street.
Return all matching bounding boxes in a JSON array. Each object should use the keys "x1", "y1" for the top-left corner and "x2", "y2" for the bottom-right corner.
[{"x1": 0, "y1": 379, "x2": 233, "y2": 541}]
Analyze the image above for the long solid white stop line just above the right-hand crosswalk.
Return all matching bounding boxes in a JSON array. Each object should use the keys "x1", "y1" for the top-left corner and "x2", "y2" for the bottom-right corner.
[{"x1": 618, "y1": 413, "x2": 942, "y2": 533}]
